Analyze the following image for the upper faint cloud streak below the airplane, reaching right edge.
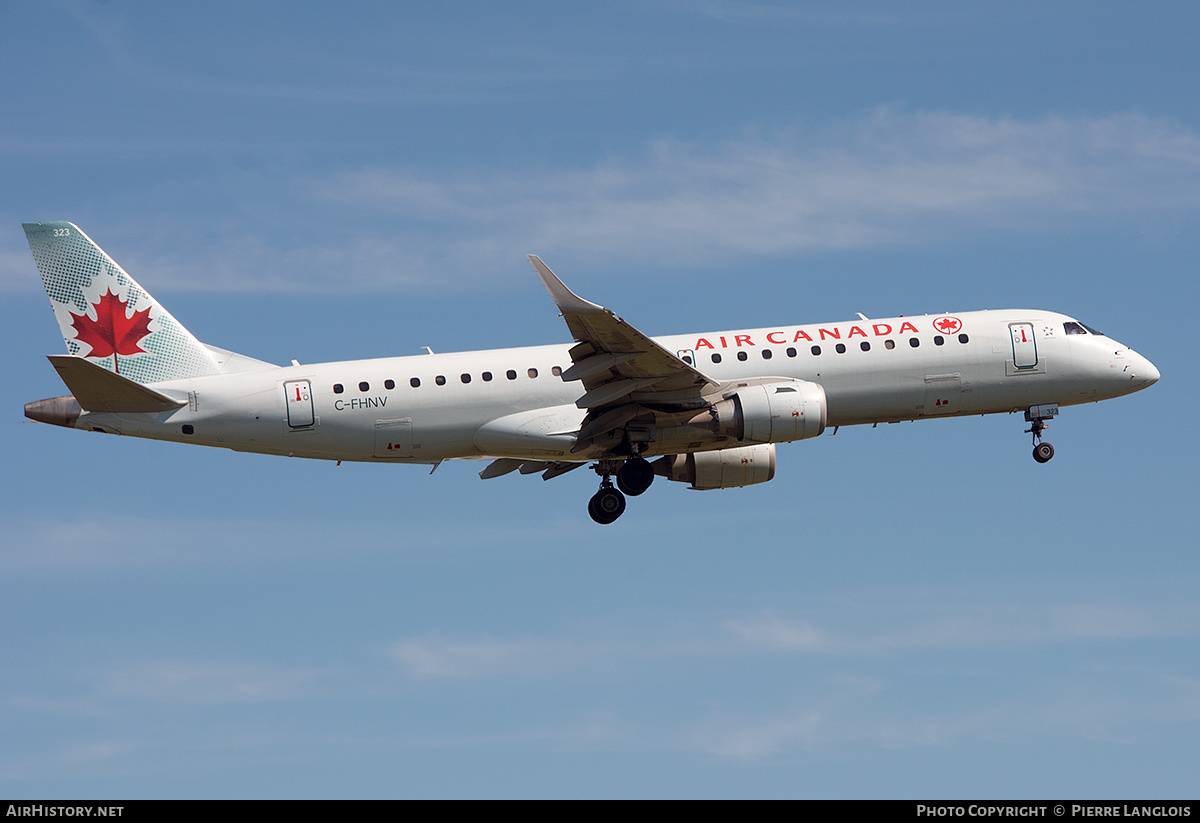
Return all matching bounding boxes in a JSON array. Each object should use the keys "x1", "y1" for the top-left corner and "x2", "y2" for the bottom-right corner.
[{"x1": 385, "y1": 595, "x2": 1200, "y2": 685}]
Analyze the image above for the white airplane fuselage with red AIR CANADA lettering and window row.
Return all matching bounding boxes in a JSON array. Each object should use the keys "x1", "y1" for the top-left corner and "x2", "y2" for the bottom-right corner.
[{"x1": 76, "y1": 310, "x2": 1158, "y2": 463}]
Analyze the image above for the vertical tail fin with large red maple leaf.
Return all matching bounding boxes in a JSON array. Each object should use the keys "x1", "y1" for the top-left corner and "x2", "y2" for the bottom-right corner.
[{"x1": 24, "y1": 222, "x2": 225, "y2": 384}]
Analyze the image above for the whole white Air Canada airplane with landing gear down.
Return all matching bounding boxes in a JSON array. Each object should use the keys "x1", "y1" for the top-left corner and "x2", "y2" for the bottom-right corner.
[{"x1": 24, "y1": 222, "x2": 1159, "y2": 524}]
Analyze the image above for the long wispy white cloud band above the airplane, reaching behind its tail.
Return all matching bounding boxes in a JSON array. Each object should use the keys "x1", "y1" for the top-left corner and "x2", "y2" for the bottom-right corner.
[{"x1": 11, "y1": 108, "x2": 1200, "y2": 294}]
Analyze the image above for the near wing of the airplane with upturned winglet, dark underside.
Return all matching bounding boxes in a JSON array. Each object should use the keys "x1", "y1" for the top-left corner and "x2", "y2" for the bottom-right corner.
[{"x1": 529, "y1": 254, "x2": 718, "y2": 451}]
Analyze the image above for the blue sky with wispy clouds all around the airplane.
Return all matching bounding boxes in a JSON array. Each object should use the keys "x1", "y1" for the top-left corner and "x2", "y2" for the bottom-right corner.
[{"x1": 0, "y1": 0, "x2": 1200, "y2": 798}]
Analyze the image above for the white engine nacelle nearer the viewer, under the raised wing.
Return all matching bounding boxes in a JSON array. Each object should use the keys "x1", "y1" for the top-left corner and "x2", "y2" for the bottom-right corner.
[{"x1": 688, "y1": 380, "x2": 828, "y2": 443}]
